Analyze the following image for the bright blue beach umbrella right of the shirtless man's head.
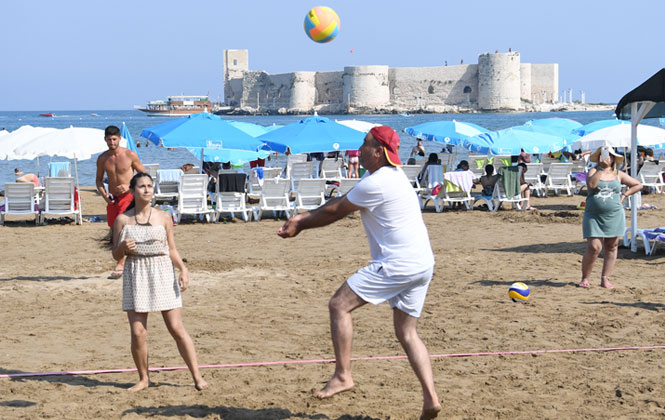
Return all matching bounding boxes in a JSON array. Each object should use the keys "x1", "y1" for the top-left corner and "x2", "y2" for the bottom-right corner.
[{"x1": 141, "y1": 112, "x2": 266, "y2": 152}]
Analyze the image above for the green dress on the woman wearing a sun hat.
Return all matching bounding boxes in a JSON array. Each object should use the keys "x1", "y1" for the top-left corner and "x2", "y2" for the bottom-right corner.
[{"x1": 582, "y1": 178, "x2": 626, "y2": 239}]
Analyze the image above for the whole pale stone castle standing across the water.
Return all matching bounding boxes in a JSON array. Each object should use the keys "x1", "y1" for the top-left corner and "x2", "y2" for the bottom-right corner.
[{"x1": 223, "y1": 50, "x2": 559, "y2": 114}]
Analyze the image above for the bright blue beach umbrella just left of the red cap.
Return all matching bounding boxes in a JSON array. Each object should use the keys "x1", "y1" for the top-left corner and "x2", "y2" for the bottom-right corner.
[{"x1": 257, "y1": 115, "x2": 365, "y2": 154}]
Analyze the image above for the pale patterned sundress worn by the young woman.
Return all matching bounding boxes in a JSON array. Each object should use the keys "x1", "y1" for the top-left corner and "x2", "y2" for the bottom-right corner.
[{"x1": 120, "y1": 225, "x2": 182, "y2": 312}]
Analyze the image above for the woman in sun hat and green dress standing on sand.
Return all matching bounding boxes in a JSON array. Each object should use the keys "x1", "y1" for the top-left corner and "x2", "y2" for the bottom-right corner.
[{"x1": 579, "y1": 147, "x2": 642, "y2": 289}]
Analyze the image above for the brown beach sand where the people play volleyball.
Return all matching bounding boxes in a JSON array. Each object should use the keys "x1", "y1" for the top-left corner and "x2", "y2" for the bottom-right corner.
[{"x1": 0, "y1": 188, "x2": 665, "y2": 420}]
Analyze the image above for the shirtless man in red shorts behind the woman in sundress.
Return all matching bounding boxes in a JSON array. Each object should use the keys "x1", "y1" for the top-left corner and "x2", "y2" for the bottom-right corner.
[{"x1": 97, "y1": 125, "x2": 146, "y2": 279}]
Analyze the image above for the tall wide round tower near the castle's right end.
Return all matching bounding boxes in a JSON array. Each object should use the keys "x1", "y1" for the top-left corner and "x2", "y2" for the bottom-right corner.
[{"x1": 478, "y1": 52, "x2": 521, "y2": 111}]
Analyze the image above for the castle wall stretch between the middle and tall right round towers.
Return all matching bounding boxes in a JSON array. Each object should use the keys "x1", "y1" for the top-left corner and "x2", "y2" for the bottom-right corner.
[{"x1": 388, "y1": 64, "x2": 478, "y2": 107}]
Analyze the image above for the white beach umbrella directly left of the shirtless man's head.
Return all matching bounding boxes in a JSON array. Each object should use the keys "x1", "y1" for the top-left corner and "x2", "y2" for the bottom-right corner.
[{"x1": 12, "y1": 127, "x2": 127, "y2": 160}]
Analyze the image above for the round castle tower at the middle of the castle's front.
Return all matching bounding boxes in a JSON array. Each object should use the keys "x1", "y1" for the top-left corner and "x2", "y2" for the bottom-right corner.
[{"x1": 342, "y1": 66, "x2": 390, "y2": 108}]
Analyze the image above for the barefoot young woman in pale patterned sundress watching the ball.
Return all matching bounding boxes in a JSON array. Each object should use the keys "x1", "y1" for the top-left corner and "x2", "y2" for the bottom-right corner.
[{"x1": 113, "y1": 172, "x2": 208, "y2": 392}]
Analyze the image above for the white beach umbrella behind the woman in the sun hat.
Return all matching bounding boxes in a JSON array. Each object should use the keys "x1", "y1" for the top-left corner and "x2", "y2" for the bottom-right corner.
[{"x1": 572, "y1": 124, "x2": 665, "y2": 150}]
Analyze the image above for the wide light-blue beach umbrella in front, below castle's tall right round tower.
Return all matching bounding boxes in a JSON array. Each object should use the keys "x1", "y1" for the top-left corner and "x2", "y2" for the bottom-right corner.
[{"x1": 462, "y1": 128, "x2": 566, "y2": 156}]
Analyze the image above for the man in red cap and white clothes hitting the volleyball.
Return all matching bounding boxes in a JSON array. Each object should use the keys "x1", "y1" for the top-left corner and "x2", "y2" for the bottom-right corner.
[{"x1": 277, "y1": 126, "x2": 441, "y2": 419}]
